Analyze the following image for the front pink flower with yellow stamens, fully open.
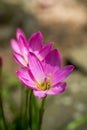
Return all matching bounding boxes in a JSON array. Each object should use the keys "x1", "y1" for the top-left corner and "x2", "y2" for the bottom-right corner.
[{"x1": 17, "y1": 49, "x2": 74, "y2": 98}]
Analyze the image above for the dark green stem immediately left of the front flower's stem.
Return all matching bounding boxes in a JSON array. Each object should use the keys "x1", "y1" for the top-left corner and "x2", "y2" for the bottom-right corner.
[{"x1": 29, "y1": 90, "x2": 33, "y2": 130}]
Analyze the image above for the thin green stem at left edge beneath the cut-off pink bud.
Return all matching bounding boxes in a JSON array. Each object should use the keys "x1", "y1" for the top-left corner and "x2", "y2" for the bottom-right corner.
[{"x1": 0, "y1": 68, "x2": 8, "y2": 130}]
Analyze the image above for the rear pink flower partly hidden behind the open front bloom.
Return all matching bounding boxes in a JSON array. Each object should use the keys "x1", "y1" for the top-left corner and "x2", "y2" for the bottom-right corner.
[{"x1": 11, "y1": 29, "x2": 53, "y2": 67}]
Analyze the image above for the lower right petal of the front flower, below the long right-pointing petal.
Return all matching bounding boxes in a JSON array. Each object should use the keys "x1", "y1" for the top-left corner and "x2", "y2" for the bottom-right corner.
[{"x1": 47, "y1": 82, "x2": 66, "y2": 95}]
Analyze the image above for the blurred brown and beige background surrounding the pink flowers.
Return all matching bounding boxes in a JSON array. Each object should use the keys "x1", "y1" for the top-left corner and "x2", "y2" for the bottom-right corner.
[{"x1": 0, "y1": 0, "x2": 87, "y2": 130}]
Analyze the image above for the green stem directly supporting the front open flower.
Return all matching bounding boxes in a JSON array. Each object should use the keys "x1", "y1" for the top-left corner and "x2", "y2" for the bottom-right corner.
[{"x1": 38, "y1": 96, "x2": 47, "y2": 130}]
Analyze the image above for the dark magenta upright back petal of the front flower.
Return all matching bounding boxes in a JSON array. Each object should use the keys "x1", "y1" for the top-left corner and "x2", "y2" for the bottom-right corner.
[{"x1": 45, "y1": 49, "x2": 62, "y2": 68}]
